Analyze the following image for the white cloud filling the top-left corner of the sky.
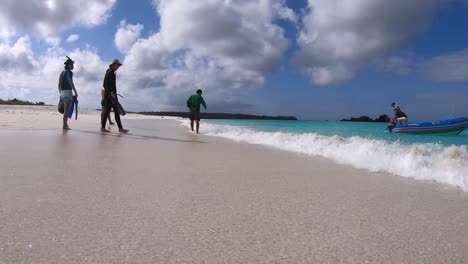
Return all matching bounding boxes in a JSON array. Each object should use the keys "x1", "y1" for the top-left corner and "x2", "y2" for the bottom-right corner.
[{"x1": 0, "y1": 0, "x2": 116, "y2": 39}]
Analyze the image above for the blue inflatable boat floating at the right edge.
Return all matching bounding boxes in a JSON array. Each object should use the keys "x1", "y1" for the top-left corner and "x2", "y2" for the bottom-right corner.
[{"x1": 388, "y1": 117, "x2": 468, "y2": 135}]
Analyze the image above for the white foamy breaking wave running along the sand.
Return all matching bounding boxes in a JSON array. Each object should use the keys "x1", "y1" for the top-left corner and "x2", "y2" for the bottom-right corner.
[{"x1": 183, "y1": 121, "x2": 468, "y2": 191}]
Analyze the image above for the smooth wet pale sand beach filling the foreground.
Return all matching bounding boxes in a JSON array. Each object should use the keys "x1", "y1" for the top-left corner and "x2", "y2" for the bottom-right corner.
[{"x1": 0, "y1": 106, "x2": 468, "y2": 264}]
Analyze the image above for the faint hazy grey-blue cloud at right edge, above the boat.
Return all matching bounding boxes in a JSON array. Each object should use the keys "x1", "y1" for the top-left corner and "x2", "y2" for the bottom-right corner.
[{"x1": 418, "y1": 48, "x2": 468, "y2": 82}]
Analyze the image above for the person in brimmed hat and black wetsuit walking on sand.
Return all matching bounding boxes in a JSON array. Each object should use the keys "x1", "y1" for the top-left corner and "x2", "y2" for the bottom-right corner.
[{"x1": 101, "y1": 59, "x2": 129, "y2": 133}]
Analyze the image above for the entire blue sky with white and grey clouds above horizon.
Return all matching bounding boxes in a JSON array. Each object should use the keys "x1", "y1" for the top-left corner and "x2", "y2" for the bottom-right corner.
[{"x1": 0, "y1": 0, "x2": 468, "y2": 121}]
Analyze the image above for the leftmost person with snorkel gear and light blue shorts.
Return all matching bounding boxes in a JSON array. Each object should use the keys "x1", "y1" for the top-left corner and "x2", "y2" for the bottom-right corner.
[{"x1": 58, "y1": 56, "x2": 78, "y2": 130}]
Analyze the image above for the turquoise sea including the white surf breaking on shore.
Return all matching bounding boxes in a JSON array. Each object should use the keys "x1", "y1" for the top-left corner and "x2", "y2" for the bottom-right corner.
[{"x1": 180, "y1": 120, "x2": 468, "y2": 191}]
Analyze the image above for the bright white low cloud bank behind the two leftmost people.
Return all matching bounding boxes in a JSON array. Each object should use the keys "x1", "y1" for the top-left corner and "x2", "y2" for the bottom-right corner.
[{"x1": 0, "y1": 37, "x2": 108, "y2": 105}]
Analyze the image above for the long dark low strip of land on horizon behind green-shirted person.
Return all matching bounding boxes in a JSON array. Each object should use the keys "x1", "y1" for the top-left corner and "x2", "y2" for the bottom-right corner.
[{"x1": 137, "y1": 112, "x2": 297, "y2": 120}]
